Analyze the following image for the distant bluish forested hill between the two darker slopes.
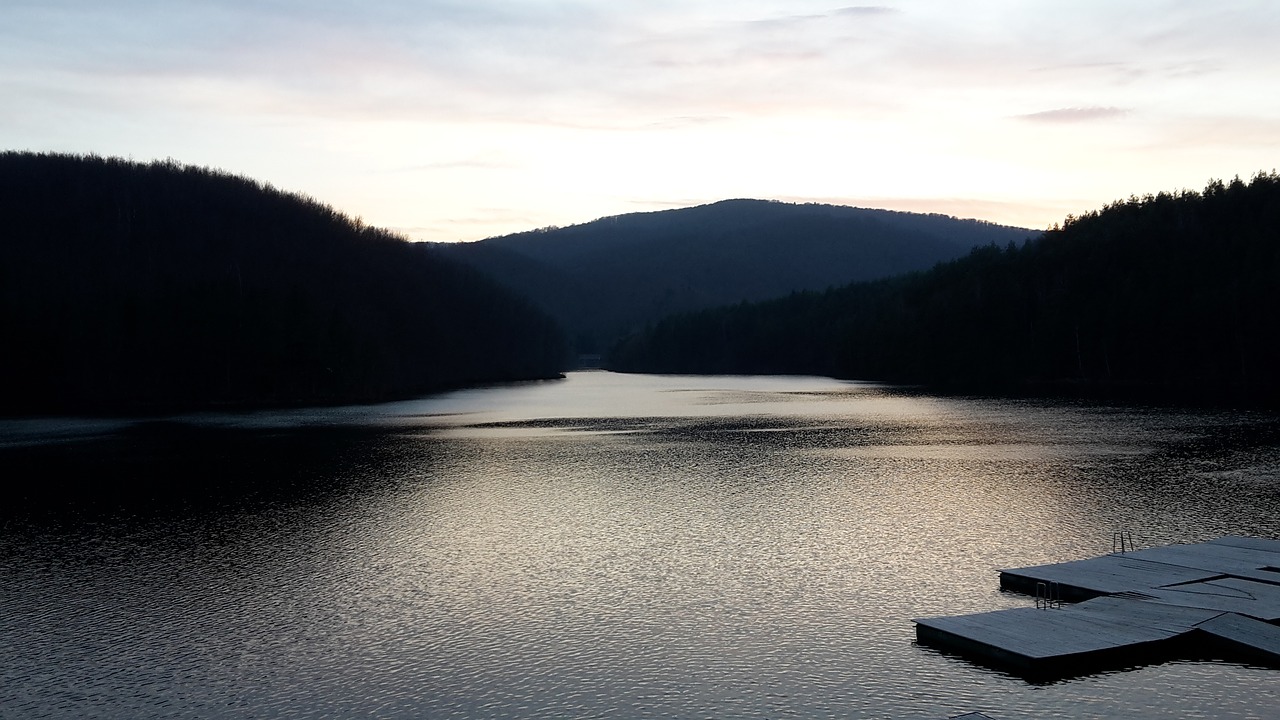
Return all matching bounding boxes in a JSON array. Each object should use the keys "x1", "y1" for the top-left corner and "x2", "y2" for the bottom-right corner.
[{"x1": 436, "y1": 200, "x2": 1033, "y2": 352}]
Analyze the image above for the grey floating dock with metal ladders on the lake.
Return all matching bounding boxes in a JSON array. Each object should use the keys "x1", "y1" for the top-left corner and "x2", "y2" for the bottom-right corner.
[{"x1": 915, "y1": 537, "x2": 1280, "y2": 676}]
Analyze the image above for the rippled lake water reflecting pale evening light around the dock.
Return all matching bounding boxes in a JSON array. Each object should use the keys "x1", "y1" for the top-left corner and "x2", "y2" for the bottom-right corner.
[{"x1": 0, "y1": 372, "x2": 1280, "y2": 720}]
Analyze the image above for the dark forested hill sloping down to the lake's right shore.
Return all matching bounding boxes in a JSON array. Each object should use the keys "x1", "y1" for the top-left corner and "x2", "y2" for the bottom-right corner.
[{"x1": 609, "y1": 173, "x2": 1280, "y2": 405}]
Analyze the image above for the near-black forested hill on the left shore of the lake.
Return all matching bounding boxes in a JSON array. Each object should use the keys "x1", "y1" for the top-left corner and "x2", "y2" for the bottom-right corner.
[{"x1": 0, "y1": 152, "x2": 567, "y2": 414}]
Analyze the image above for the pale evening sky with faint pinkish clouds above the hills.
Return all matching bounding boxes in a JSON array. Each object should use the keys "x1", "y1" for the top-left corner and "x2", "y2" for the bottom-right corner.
[{"x1": 0, "y1": 0, "x2": 1280, "y2": 241}]
